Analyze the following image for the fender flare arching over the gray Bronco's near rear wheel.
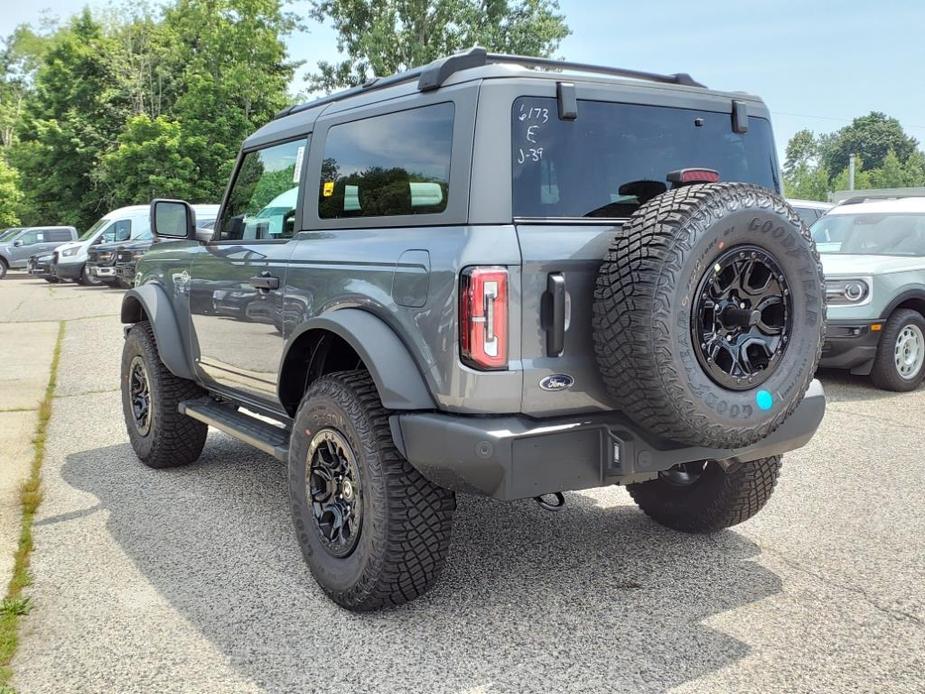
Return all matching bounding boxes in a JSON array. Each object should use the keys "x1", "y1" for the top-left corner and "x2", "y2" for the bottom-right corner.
[{"x1": 282, "y1": 308, "x2": 437, "y2": 410}]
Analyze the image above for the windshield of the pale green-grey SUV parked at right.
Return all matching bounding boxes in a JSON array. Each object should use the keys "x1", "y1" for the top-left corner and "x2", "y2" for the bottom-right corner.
[{"x1": 812, "y1": 214, "x2": 925, "y2": 256}]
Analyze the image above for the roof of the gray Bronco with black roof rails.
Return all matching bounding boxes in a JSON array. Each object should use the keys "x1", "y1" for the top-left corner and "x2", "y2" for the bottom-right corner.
[{"x1": 244, "y1": 47, "x2": 764, "y2": 148}]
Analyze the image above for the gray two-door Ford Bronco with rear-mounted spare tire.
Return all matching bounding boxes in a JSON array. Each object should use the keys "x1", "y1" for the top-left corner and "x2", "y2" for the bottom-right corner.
[{"x1": 122, "y1": 48, "x2": 825, "y2": 610}]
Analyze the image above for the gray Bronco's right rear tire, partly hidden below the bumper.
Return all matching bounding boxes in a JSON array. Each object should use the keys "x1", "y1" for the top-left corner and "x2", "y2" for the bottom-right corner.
[{"x1": 626, "y1": 456, "x2": 780, "y2": 533}]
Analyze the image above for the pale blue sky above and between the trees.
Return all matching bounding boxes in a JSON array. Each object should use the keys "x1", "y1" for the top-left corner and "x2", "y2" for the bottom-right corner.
[{"x1": 0, "y1": 0, "x2": 925, "y2": 160}]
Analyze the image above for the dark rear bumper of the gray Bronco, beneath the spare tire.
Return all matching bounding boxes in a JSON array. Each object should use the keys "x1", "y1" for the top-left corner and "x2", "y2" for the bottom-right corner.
[{"x1": 391, "y1": 381, "x2": 825, "y2": 499}]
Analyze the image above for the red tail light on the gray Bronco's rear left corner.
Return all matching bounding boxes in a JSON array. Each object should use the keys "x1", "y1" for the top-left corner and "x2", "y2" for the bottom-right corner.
[{"x1": 459, "y1": 267, "x2": 508, "y2": 370}]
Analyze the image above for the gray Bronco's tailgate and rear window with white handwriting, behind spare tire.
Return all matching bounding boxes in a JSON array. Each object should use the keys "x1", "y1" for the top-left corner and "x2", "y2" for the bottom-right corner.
[{"x1": 511, "y1": 95, "x2": 780, "y2": 415}]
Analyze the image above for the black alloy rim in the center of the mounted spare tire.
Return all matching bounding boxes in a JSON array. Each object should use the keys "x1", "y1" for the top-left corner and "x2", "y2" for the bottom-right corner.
[{"x1": 691, "y1": 245, "x2": 793, "y2": 390}]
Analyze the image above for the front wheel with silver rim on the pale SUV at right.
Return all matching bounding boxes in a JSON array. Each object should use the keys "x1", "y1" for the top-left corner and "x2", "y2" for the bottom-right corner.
[{"x1": 870, "y1": 308, "x2": 925, "y2": 392}]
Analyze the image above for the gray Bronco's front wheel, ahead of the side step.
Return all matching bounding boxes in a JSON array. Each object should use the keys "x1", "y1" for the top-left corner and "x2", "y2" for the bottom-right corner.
[{"x1": 122, "y1": 321, "x2": 209, "y2": 468}]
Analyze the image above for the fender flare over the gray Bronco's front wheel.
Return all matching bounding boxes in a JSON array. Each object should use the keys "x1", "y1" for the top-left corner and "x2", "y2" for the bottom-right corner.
[{"x1": 120, "y1": 283, "x2": 195, "y2": 381}]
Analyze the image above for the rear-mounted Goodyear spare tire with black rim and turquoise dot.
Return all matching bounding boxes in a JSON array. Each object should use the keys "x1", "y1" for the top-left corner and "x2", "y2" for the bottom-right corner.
[{"x1": 593, "y1": 183, "x2": 825, "y2": 448}]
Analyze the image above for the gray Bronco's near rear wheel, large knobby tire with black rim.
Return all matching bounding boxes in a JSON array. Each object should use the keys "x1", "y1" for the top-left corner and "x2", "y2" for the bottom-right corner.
[{"x1": 289, "y1": 371, "x2": 456, "y2": 611}]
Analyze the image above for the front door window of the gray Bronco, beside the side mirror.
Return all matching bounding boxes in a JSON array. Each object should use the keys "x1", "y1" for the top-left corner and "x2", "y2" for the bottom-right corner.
[{"x1": 219, "y1": 138, "x2": 309, "y2": 241}]
